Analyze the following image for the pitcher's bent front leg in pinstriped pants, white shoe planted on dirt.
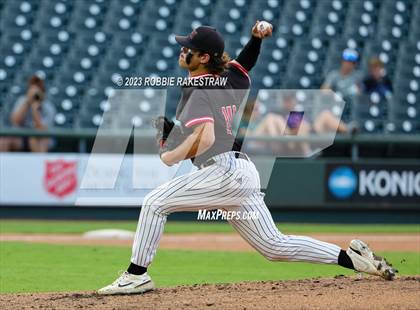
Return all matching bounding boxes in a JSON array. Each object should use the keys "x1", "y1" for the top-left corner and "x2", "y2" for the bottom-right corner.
[{"x1": 98, "y1": 158, "x2": 247, "y2": 295}]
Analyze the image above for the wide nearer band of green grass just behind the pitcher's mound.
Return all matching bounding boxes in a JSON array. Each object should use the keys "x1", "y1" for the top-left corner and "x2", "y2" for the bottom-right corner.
[{"x1": 0, "y1": 242, "x2": 420, "y2": 293}]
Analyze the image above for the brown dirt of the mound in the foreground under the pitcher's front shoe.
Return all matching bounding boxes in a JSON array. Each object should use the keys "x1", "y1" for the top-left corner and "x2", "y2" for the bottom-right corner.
[{"x1": 0, "y1": 276, "x2": 420, "y2": 309}]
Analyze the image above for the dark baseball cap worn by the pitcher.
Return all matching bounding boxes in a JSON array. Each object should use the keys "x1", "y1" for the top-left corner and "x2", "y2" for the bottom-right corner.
[{"x1": 175, "y1": 26, "x2": 225, "y2": 57}]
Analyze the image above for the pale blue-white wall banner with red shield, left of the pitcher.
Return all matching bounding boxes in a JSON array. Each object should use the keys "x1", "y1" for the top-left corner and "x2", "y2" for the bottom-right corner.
[{"x1": 0, "y1": 153, "x2": 184, "y2": 207}]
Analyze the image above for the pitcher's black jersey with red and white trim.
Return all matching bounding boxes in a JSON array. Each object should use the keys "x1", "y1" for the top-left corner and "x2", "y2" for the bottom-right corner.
[{"x1": 176, "y1": 61, "x2": 250, "y2": 166}]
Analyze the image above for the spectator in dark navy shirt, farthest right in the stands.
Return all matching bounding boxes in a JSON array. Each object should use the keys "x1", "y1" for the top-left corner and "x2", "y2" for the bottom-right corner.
[{"x1": 360, "y1": 57, "x2": 392, "y2": 99}]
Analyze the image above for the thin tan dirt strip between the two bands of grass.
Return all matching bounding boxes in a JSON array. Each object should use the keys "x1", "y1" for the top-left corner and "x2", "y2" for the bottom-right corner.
[{"x1": 0, "y1": 233, "x2": 420, "y2": 252}]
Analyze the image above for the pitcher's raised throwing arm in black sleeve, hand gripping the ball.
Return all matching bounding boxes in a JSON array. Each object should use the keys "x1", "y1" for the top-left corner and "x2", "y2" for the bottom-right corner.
[{"x1": 233, "y1": 21, "x2": 273, "y2": 71}]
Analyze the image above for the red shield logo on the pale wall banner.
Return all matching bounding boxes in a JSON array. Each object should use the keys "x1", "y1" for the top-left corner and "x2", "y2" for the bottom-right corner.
[{"x1": 44, "y1": 159, "x2": 77, "y2": 198}]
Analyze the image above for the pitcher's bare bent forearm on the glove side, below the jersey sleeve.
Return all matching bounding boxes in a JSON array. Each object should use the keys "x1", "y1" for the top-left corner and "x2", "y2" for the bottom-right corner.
[{"x1": 160, "y1": 122, "x2": 215, "y2": 166}]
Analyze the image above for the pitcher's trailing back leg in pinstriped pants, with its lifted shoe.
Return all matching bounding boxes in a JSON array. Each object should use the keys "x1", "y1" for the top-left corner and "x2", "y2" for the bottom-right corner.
[{"x1": 230, "y1": 192, "x2": 395, "y2": 280}]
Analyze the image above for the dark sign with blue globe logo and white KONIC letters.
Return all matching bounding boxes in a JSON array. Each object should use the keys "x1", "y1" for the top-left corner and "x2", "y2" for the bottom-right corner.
[{"x1": 325, "y1": 164, "x2": 420, "y2": 204}]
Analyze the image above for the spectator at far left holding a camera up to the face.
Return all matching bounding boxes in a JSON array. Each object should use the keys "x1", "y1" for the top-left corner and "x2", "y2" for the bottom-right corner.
[{"x1": 0, "y1": 75, "x2": 55, "y2": 152}]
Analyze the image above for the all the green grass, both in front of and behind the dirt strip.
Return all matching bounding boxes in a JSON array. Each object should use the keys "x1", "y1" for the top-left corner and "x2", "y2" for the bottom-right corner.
[{"x1": 0, "y1": 220, "x2": 420, "y2": 293}]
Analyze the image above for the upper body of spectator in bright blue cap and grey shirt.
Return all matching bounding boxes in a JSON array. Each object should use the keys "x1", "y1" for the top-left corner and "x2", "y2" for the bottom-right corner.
[{"x1": 321, "y1": 49, "x2": 360, "y2": 99}]
